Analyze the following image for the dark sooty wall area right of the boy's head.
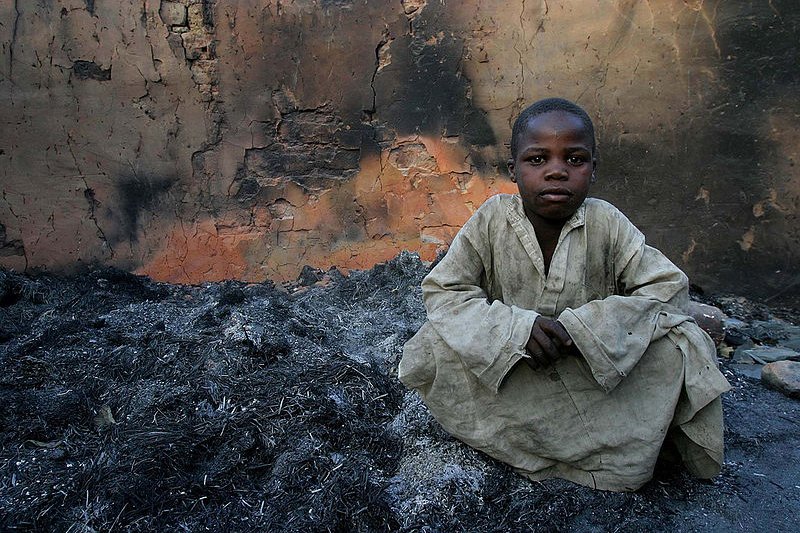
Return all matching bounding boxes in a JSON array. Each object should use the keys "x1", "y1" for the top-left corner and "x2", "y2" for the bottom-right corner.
[{"x1": 593, "y1": 1, "x2": 800, "y2": 304}]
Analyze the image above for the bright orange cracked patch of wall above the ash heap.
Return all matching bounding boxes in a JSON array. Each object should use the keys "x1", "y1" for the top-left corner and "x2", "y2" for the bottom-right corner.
[{"x1": 139, "y1": 138, "x2": 516, "y2": 283}]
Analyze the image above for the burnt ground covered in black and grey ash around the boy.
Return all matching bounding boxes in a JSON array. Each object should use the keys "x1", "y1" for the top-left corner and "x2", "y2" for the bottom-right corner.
[{"x1": 0, "y1": 254, "x2": 800, "y2": 532}]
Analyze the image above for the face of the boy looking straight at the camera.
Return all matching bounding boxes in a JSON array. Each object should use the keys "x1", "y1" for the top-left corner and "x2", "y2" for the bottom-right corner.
[{"x1": 508, "y1": 111, "x2": 595, "y2": 227}]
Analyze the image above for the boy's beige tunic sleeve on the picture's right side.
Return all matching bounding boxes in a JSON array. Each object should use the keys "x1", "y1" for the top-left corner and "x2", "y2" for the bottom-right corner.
[{"x1": 558, "y1": 210, "x2": 689, "y2": 391}]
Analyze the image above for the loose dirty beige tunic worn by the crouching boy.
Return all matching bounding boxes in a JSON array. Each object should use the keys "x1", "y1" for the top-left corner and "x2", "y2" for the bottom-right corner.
[{"x1": 399, "y1": 195, "x2": 729, "y2": 490}]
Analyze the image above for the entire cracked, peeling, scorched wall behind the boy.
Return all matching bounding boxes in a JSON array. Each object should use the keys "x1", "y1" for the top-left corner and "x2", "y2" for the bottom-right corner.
[{"x1": 0, "y1": 0, "x2": 800, "y2": 302}]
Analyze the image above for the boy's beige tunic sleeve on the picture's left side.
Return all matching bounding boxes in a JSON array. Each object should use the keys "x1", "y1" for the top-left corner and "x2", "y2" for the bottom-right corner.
[{"x1": 422, "y1": 206, "x2": 539, "y2": 392}]
